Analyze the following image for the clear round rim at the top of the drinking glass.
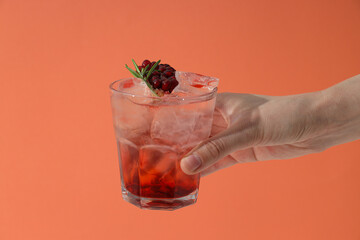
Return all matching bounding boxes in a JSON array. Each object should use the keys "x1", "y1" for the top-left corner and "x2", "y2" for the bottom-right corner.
[{"x1": 109, "y1": 77, "x2": 218, "y2": 102}]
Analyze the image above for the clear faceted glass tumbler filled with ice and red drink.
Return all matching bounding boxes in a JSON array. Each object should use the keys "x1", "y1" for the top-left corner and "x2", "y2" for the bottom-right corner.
[{"x1": 110, "y1": 72, "x2": 218, "y2": 210}]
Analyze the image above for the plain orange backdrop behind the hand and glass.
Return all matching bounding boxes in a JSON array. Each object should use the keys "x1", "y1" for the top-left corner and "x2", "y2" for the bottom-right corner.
[{"x1": 0, "y1": 0, "x2": 360, "y2": 240}]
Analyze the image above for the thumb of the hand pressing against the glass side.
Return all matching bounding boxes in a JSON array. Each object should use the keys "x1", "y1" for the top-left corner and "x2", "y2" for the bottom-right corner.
[{"x1": 180, "y1": 120, "x2": 259, "y2": 175}]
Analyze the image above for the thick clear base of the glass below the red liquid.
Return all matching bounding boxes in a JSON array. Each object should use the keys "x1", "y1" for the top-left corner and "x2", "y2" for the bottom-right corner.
[{"x1": 122, "y1": 187, "x2": 198, "y2": 211}]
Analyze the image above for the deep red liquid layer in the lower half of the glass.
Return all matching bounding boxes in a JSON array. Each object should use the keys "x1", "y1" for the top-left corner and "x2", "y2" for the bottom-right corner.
[{"x1": 118, "y1": 140, "x2": 199, "y2": 206}]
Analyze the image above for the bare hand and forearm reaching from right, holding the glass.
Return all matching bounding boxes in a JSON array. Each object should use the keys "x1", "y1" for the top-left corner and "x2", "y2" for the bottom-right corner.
[{"x1": 180, "y1": 75, "x2": 360, "y2": 176}]
